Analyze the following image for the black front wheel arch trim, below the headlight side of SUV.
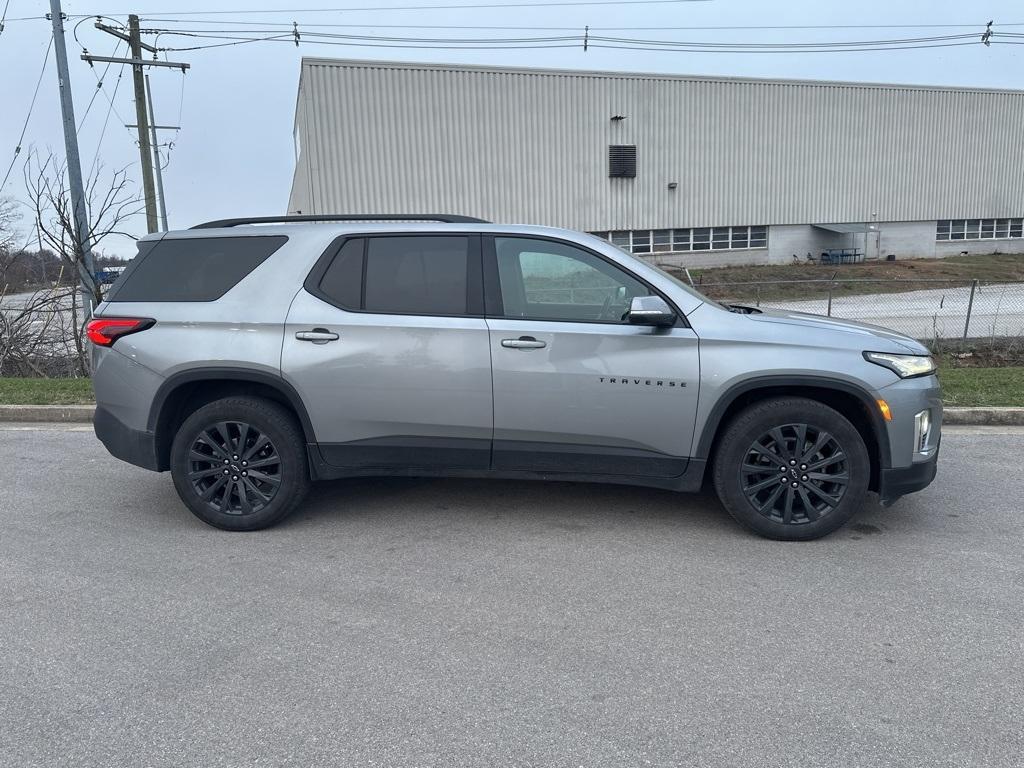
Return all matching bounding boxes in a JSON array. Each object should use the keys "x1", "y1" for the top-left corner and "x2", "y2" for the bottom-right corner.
[{"x1": 693, "y1": 376, "x2": 892, "y2": 490}]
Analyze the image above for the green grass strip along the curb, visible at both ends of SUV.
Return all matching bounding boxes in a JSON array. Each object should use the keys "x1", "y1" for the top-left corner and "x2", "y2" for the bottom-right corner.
[{"x1": 0, "y1": 367, "x2": 1024, "y2": 407}]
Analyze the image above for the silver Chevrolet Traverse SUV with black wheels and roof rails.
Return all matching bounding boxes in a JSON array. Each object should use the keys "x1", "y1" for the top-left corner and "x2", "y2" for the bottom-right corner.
[{"x1": 88, "y1": 216, "x2": 942, "y2": 540}]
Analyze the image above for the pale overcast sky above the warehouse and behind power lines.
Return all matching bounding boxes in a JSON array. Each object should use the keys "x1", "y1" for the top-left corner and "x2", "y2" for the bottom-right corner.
[{"x1": 0, "y1": 0, "x2": 1024, "y2": 256}]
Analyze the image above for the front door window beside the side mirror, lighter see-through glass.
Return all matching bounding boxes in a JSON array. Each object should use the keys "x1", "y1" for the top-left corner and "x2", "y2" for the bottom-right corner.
[{"x1": 495, "y1": 238, "x2": 650, "y2": 323}]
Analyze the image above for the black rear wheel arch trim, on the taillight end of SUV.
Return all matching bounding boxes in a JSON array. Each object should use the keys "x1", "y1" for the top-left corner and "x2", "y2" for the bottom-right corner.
[{"x1": 147, "y1": 367, "x2": 316, "y2": 471}]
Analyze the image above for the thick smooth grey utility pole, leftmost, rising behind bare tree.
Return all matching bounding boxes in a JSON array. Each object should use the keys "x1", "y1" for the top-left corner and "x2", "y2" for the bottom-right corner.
[{"x1": 50, "y1": 0, "x2": 96, "y2": 318}]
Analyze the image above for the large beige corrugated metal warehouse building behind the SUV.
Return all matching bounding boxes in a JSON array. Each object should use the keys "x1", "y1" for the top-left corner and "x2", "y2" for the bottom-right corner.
[{"x1": 289, "y1": 58, "x2": 1024, "y2": 265}]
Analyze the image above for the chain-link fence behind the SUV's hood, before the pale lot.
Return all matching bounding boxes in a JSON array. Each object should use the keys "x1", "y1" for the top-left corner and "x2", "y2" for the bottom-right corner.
[{"x1": 695, "y1": 279, "x2": 1024, "y2": 344}]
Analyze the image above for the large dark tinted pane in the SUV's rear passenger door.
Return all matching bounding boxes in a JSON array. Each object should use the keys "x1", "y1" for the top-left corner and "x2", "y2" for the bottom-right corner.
[{"x1": 364, "y1": 237, "x2": 469, "y2": 314}]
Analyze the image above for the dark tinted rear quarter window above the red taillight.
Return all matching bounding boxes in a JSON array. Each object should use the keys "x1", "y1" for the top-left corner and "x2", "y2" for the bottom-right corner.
[{"x1": 111, "y1": 236, "x2": 288, "y2": 301}]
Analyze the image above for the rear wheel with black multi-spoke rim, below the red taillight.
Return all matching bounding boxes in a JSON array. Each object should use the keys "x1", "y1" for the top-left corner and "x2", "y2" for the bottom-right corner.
[{"x1": 171, "y1": 397, "x2": 310, "y2": 530}]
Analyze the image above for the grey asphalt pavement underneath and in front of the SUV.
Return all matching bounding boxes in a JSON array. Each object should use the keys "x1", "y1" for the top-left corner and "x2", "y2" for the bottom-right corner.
[{"x1": 0, "y1": 425, "x2": 1024, "y2": 768}]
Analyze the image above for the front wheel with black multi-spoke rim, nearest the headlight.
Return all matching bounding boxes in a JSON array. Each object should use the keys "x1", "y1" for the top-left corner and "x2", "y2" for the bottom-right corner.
[{"x1": 714, "y1": 397, "x2": 871, "y2": 541}]
